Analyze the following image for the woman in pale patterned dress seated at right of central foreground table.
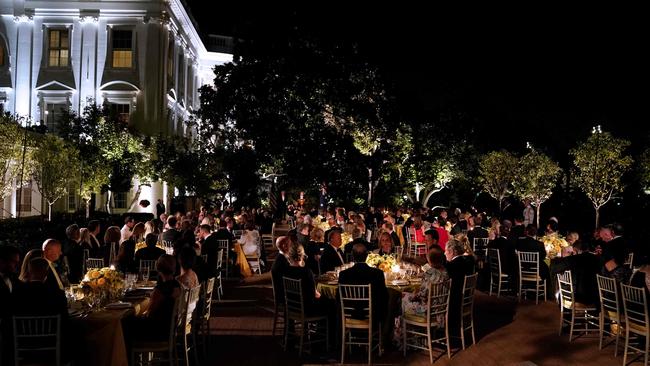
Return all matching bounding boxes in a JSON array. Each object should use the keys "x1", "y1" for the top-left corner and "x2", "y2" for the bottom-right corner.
[{"x1": 402, "y1": 246, "x2": 449, "y2": 324}]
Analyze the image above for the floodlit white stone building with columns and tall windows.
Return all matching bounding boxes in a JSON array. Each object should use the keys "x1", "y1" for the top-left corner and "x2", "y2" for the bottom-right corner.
[{"x1": 0, "y1": 0, "x2": 232, "y2": 217}]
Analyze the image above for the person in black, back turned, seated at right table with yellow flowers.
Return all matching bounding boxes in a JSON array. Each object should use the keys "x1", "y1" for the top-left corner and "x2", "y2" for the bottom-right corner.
[{"x1": 553, "y1": 241, "x2": 600, "y2": 305}]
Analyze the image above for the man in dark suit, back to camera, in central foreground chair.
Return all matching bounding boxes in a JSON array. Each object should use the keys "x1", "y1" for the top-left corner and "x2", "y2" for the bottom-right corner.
[{"x1": 339, "y1": 244, "x2": 390, "y2": 326}]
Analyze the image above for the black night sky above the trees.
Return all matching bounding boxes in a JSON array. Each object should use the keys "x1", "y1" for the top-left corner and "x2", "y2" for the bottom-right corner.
[{"x1": 188, "y1": 0, "x2": 650, "y2": 162}]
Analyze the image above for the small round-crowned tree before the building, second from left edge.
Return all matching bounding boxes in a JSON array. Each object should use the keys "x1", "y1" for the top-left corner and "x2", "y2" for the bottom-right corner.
[{"x1": 32, "y1": 134, "x2": 79, "y2": 220}]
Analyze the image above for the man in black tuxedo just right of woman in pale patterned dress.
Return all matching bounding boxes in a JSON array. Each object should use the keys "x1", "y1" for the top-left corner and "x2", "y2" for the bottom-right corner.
[{"x1": 445, "y1": 239, "x2": 474, "y2": 335}]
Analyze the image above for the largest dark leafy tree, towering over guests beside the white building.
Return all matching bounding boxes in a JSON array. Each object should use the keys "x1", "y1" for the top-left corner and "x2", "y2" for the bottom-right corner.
[{"x1": 193, "y1": 37, "x2": 397, "y2": 209}]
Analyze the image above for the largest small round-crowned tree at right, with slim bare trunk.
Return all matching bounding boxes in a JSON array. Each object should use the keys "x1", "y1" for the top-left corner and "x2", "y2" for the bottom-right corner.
[{"x1": 570, "y1": 132, "x2": 632, "y2": 227}]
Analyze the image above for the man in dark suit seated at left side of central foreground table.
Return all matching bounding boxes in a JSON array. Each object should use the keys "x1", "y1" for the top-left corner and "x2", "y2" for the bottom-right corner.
[{"x1": 283, "y1": 244, "x2": 327, "y2": 316}]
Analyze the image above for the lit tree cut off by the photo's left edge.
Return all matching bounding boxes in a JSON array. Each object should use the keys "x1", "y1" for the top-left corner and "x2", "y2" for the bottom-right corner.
[{"x1": 0, "y1": 114, "x2": 29, "y2": 202}]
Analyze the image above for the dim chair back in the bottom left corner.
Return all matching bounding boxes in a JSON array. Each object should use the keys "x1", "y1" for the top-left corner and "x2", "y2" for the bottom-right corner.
[{"x1": 13, "y1": 315, "x2": 61, "y2": 365}]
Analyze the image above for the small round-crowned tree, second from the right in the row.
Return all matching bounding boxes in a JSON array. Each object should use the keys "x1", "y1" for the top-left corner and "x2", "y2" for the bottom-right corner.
[{"x1": 512, "y1": 149, "x2": 561, "y2": 227}]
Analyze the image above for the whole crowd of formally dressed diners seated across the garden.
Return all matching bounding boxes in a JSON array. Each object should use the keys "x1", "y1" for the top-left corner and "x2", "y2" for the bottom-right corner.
[{"x1": 0, "y1": 204, "x2": 650, "y2": 362}]
